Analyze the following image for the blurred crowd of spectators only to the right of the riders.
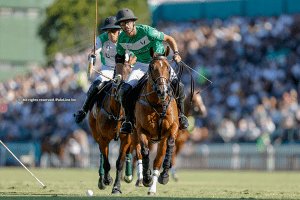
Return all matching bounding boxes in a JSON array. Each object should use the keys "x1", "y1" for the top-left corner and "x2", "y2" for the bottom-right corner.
[{"x1": 158, "y1": 14, "x2": 300, "y2": 144}]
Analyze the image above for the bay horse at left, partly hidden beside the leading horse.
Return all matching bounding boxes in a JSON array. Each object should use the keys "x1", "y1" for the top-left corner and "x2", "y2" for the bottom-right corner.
[{"x1": 89, "y1": 57, "x2": 134, "y2": 194}]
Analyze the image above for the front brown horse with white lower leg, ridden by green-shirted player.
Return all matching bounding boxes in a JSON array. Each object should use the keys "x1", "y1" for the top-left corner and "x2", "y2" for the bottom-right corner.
[{"x1": 132, "y1": 47, "x2": 179, "y2": 194}]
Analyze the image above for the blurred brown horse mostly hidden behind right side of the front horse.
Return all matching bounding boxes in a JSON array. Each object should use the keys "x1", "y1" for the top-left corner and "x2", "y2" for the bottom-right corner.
[{"x1": 172, "y1": 88, "x2": 207, "y2": 181}]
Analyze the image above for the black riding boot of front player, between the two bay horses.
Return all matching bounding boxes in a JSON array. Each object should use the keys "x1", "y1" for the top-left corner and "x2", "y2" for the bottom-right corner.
[{"x1": 119, "y1": 83, "x2": 133, "y2": 134}]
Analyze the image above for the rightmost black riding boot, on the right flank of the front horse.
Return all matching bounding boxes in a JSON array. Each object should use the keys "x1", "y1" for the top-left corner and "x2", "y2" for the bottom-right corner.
[{"x1": 172, "y1": 79, "x2": 189, "y2": 129}]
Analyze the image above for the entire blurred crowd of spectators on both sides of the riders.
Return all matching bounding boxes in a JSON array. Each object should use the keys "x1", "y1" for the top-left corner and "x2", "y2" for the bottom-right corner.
[{"x1": 0, "y1": 12, "x2": 300, "y2": 155}]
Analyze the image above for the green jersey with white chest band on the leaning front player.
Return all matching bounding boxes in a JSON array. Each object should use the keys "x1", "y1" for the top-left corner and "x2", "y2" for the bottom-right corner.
[{"x1": 117, "y1": 25, "x2": 165, "y2": 63}]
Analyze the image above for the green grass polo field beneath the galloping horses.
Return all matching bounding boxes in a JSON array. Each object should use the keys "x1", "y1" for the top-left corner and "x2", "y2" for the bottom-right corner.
[{"x1": 0, "y1": 168, "x2": 300, "y2": 200}]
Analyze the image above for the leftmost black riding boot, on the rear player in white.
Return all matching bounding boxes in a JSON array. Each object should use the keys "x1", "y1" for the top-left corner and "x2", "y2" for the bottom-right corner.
[{"x1": 74, "y1": 80, "x2": 104, "y2": 124}]
